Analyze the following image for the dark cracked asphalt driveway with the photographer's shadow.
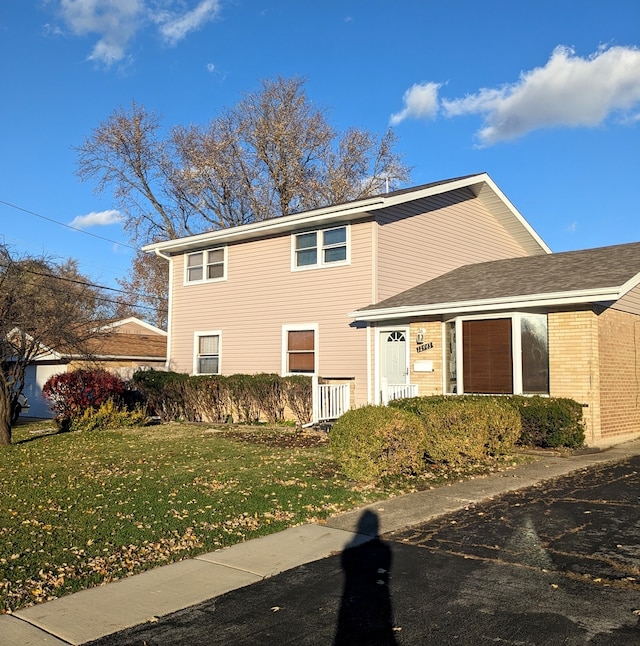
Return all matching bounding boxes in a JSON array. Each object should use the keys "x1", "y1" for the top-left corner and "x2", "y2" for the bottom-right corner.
[{"x1": 86, "y1": 456, "x2": 640, "y2": 646}]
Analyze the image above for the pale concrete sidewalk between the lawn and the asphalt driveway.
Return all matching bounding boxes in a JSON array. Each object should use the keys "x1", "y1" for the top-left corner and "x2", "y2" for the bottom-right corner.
[{"x1": 5, "y1": 440, "x2": 640, "y2": 646}]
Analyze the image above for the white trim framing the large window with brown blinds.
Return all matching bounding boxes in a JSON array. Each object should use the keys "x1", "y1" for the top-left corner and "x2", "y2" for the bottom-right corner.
[{"x1": 442, "y1": 311, "x2": 549, "y2": 397}]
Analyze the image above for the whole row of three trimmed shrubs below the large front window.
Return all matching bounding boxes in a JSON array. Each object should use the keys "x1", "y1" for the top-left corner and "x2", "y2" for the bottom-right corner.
[{"x1": 329, "y1": 395, "x2": 584, "y2": 482}]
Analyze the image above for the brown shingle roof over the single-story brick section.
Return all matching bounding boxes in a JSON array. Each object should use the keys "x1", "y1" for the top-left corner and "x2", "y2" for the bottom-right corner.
[{"x1": 358, "y1": 242, "x2": 640, "y2": 312}]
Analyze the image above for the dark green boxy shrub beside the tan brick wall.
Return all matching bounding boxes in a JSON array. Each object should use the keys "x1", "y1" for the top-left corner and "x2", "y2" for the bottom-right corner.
[{"x1": 509, "y1": 396, "x2": 585, "y2": 448}]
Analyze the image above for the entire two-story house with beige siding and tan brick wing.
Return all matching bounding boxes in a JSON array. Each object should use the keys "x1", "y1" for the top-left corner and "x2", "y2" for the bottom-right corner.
[{"x1": 144, "y1": 173, "x2": 640, "y2": 445}]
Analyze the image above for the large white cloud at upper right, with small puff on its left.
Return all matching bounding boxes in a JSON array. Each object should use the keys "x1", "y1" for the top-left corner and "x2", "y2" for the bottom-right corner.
[{"x1": 391, "y1": 47, "x2": 640, "y2": 145}]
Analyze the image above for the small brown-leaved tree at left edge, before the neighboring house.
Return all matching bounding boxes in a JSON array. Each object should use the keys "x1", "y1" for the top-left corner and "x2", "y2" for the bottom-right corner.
[{"x1": 0, "y1": 247, "x2": 106, "y2": 446}]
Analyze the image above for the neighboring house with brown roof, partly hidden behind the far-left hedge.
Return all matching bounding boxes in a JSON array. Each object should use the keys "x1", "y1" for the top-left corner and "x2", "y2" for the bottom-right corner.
[{"x1": 23, "y1": 317, "x2": 167, "y2": 418}]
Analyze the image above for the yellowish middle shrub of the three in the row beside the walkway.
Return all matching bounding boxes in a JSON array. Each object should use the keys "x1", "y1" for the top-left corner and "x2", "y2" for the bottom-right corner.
[{"x1": 390, "y1": 396, "x2": 520, "y2": 465}]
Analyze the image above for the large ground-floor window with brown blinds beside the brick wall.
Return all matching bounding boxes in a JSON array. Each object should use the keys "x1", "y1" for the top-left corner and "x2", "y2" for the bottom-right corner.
[{"x1": 445, "y1": 314, "x2": 549, "y2": 395}]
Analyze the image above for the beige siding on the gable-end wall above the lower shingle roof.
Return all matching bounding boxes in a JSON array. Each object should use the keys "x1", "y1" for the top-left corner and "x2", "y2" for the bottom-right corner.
[{"x1": 374, "y1": 188, "x2": 528, "y2": 300}]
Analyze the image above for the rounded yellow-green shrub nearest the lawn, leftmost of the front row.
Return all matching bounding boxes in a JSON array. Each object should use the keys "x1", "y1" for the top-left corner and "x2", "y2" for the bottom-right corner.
[{"x1": 329, "y1": 406, "x2": 425, "y2": 482}]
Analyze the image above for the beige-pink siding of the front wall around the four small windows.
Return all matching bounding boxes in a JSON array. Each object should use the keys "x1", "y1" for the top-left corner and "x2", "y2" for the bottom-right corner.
[{"x1": 170, "y1": 222, "x2": 371, "y2": 402}]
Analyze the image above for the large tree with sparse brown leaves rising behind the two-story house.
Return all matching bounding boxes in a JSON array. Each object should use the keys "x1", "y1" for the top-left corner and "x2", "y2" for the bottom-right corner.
[{"x1": 77, "y1": 77, "x2": 409, "y2": 326}]
